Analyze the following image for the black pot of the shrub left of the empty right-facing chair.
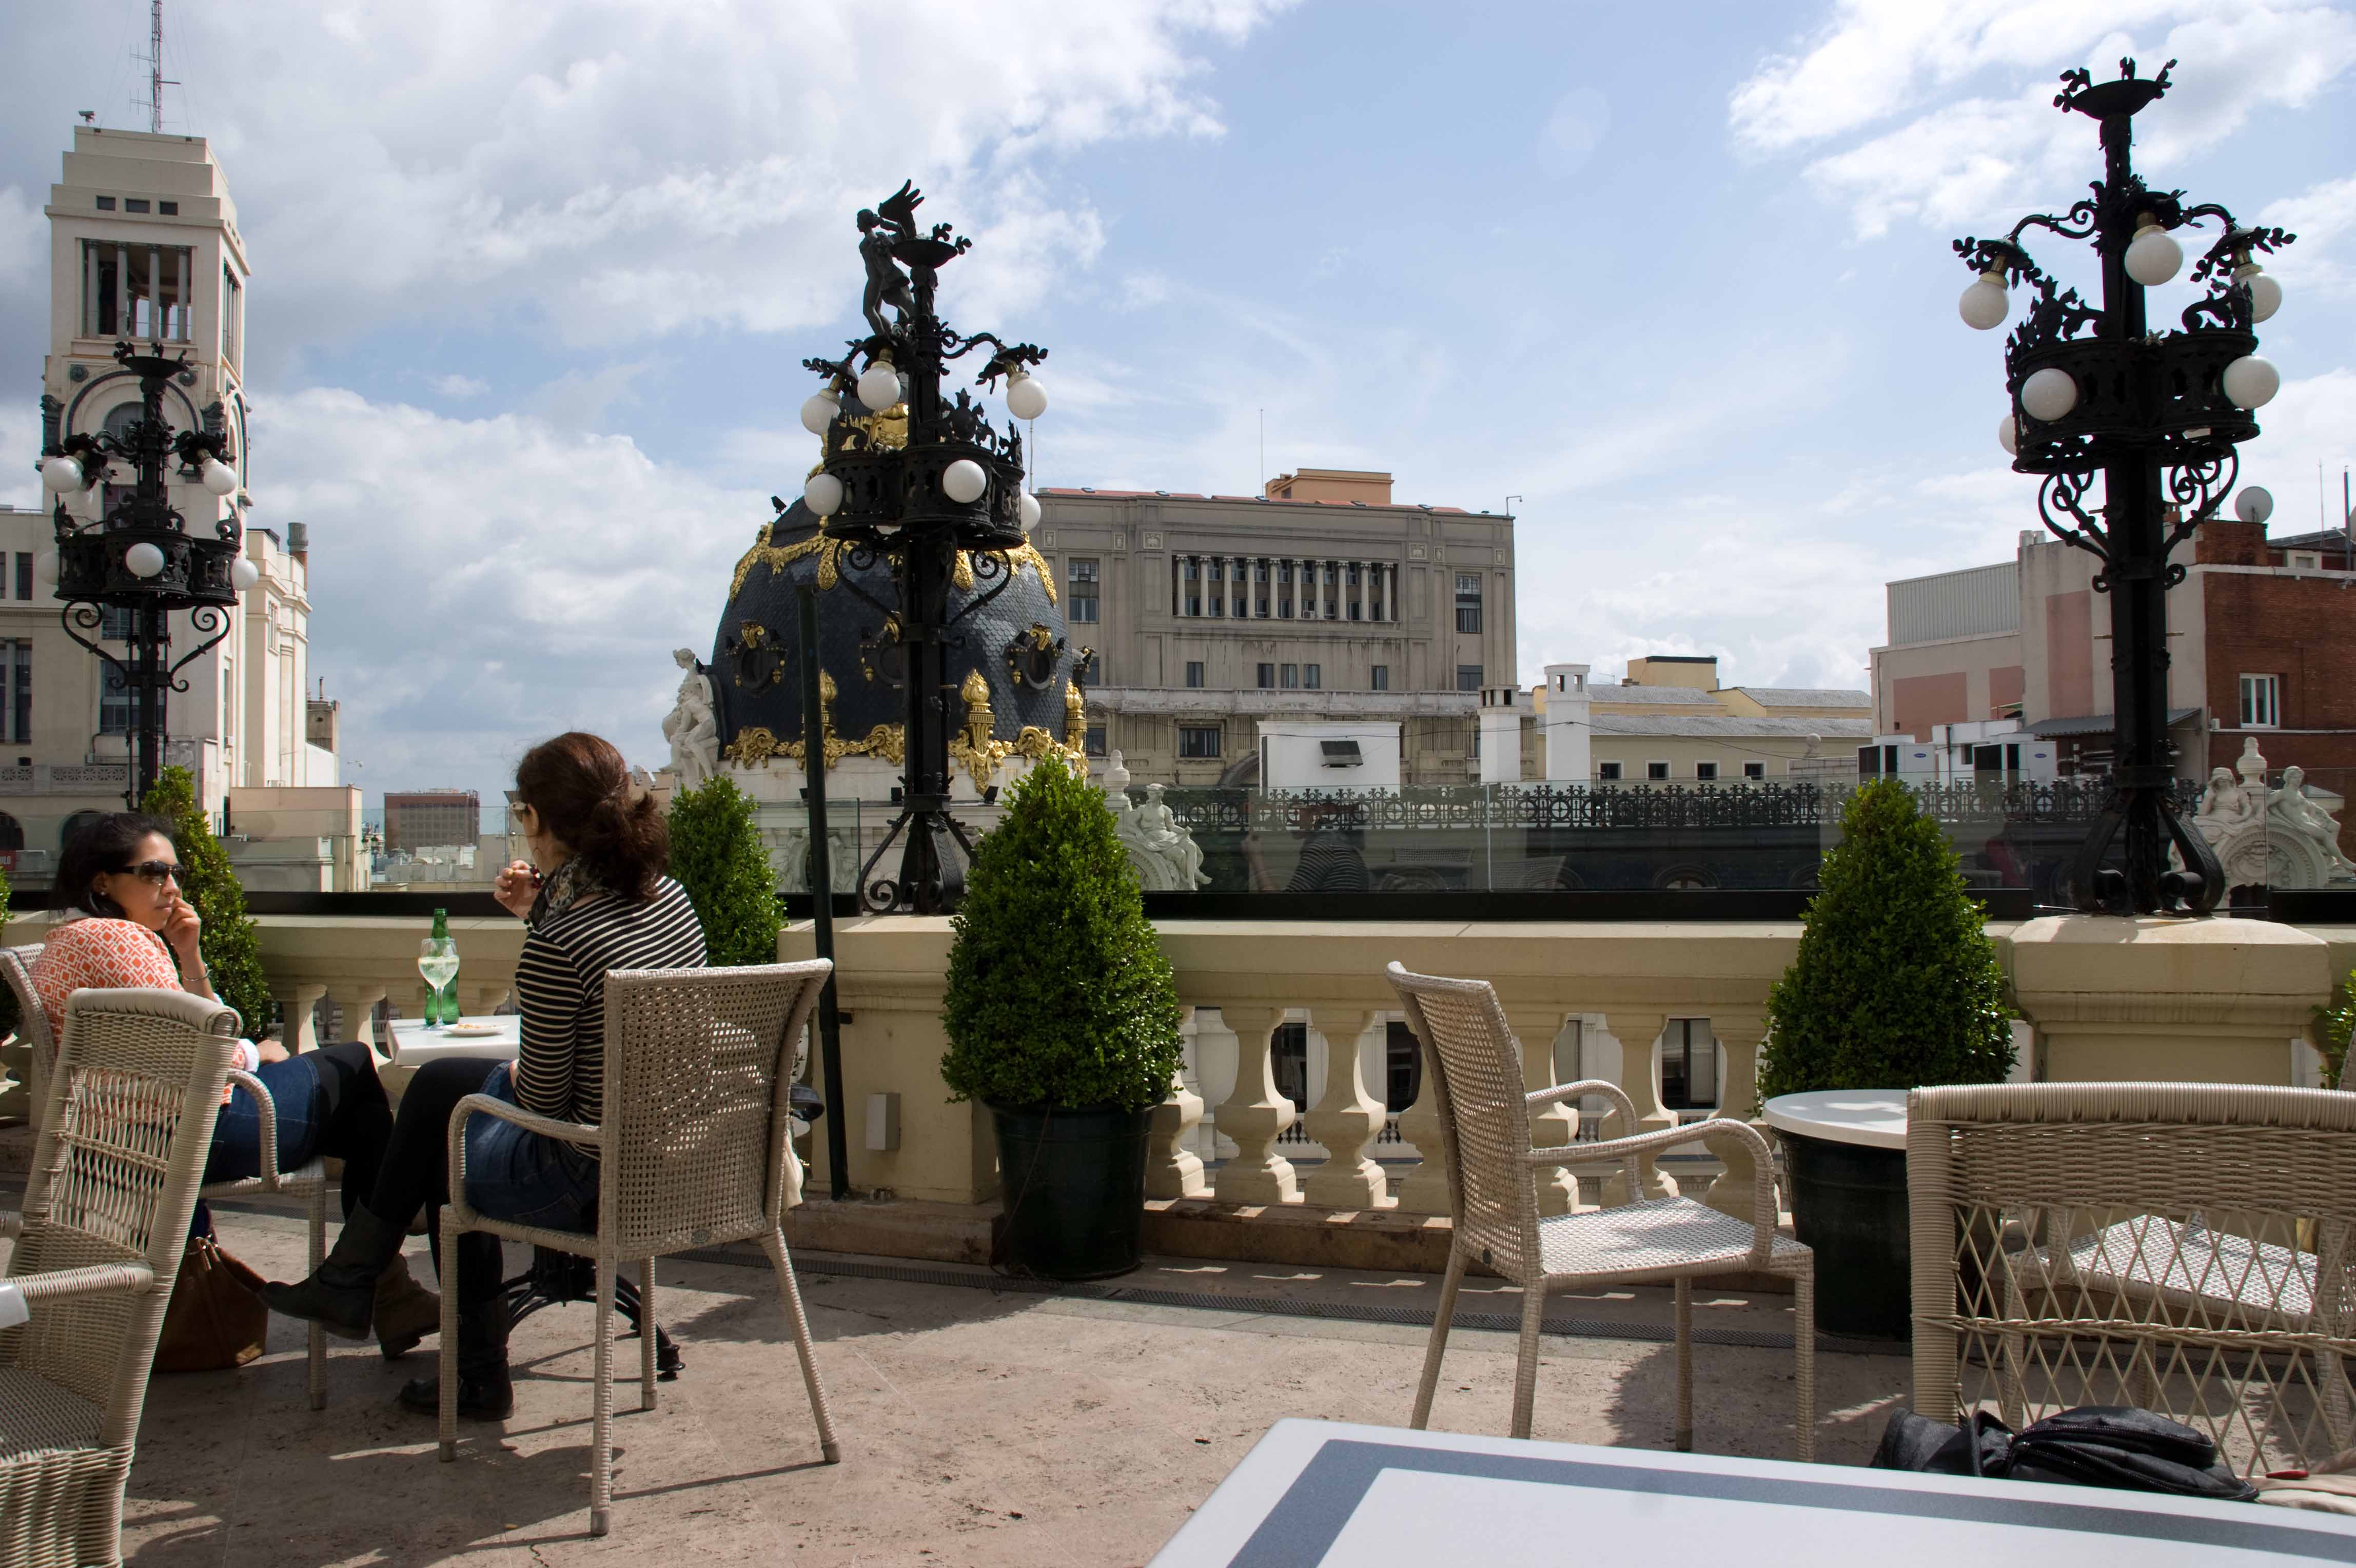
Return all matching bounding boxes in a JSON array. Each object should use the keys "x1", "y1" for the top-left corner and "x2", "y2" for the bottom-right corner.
[{"x1": 990, "y1": 1104, "x2": 1154, "y2": 1279}]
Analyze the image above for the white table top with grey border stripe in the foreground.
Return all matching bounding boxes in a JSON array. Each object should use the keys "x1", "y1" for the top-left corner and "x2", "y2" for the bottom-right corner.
[{"x1": 1152, "y1": 1420, "x2": 2356, "y2": 1568}]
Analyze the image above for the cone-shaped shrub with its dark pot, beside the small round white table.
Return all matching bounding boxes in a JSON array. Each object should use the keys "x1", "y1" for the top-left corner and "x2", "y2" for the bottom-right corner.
[{"x1": 1760, "y1": 779, "x2": 2012, "y2": 1340}]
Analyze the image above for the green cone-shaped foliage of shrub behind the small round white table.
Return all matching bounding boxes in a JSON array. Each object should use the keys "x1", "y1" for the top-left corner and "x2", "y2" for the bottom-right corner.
[{"x1": 1760, "y1": 779, "x2": 2014, "y2": 1100}]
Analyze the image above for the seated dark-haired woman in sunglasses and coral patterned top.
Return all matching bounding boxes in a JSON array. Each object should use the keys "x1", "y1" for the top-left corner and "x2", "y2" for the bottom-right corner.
[{"x1": 31, "y1": 812, "x2": 441, "y2": 1361}]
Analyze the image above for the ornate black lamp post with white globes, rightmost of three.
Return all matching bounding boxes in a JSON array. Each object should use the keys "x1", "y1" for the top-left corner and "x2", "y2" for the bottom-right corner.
[{"x1": 1955, "y1": 59, "x2": 2292, "y2": 913}]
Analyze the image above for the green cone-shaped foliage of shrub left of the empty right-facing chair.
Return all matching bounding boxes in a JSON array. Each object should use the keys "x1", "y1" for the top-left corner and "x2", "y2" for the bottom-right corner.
[{"x1": 940, "y1": 756, "x2": 1181, "y2": 1109}]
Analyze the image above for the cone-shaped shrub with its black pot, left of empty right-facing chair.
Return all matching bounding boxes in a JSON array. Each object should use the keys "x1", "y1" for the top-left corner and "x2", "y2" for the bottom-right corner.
[{"x1": 940, "y1": 753, "x2": 1181, "y2": 1279}]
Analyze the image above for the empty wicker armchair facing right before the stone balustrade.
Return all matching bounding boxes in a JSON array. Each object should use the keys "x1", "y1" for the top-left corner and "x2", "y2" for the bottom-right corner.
[{"x1": 1385, "y1": 963, "x2": 1816, "y2": 1462}]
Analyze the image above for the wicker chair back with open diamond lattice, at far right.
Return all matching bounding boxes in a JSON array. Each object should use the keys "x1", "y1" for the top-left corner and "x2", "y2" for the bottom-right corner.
[{"x1": 1906, "y1": 1083, "x2": 2356, "y2": 1472}]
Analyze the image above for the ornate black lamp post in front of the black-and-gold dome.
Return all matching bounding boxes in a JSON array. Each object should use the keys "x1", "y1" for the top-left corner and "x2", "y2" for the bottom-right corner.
[{"x1": 801, "y1": 184, "x2": 1046, "y2": 913}]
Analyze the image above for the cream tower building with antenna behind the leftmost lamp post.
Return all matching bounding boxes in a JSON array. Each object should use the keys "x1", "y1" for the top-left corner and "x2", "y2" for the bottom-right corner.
[{"x1": 0, "y1": 125, "x2": 358, "y2": 888}]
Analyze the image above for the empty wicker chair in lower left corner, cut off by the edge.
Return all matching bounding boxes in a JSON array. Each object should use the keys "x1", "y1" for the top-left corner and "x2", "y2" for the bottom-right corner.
[{"x1": 0, "y1": 991, "x2": 238, "y2": 1568}]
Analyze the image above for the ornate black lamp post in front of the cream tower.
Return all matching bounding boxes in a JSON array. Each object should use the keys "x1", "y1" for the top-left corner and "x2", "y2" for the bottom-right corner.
[{"x1": 40, "y1": 341, "x2": 259, "y2": 808}]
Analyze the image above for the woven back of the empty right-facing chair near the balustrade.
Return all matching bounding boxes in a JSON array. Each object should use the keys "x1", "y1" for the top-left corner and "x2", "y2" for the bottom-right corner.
[{"x1": 1388, "y1": 963, "x2": 1539, "y2": 1279}]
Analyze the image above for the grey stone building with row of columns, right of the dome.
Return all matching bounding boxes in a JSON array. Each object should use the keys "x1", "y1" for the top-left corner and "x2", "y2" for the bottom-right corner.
[{"x1": 1032, "y1": 468, "x2": 1515, "y2": 784}]
